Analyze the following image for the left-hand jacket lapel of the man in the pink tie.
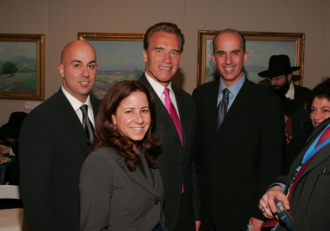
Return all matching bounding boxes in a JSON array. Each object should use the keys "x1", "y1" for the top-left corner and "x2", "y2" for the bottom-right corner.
[{"x1": 139, "y1": 74, "x2": 181, "y2": 143}]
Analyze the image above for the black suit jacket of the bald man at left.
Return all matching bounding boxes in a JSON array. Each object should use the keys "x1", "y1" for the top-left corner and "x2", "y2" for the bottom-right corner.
[{"x1": 19, "y1": 89, "x2": 100, "y2": 231}]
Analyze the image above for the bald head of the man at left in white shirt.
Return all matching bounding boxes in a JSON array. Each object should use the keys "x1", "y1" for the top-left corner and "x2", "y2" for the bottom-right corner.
[{"x1": 58, "y1": 41, "x2": 98, "y2": 103}]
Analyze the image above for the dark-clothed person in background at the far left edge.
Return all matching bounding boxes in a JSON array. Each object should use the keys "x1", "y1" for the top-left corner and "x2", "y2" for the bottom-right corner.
[{"x1": 0, "y1": 112, "x2": 27, "y2": 185}]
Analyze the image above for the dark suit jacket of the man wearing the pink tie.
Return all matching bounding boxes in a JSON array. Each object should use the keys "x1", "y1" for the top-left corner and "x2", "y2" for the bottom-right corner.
[{"x1": 138, "y1": 75, "x2": 199, "y2": 231}]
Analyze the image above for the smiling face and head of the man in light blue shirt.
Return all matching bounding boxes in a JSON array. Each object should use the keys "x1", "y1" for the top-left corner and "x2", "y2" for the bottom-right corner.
[{"x1": 211, "y1": 32, "x2": 249, "y2": 87}]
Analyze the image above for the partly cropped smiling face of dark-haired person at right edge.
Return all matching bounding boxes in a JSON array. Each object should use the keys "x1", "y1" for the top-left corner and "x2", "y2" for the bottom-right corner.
[{"x1": 310, "y1": 97, "x2": 330, "y2": 128}]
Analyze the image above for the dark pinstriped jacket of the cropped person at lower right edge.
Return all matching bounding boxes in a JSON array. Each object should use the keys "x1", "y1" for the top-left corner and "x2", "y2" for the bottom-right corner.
[{"x1": 274, "y1": 119, "x2": 330, "y2": 231}]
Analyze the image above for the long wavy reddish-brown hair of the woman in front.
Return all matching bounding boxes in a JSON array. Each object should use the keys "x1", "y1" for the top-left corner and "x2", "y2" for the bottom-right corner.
[{"x1": 90, "y1": 80, "x2": 162, "y2": 171}]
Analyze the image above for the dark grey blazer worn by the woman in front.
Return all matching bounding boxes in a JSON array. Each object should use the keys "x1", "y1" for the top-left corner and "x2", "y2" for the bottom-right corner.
[{"x1": 79, "y1": 147, "x2": 166, "y2": 231}]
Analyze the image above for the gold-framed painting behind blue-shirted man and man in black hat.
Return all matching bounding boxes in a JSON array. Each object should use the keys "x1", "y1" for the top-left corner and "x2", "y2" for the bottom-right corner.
[{"x1": 197, "y1": 31, "x2": 305, "y2": 86}]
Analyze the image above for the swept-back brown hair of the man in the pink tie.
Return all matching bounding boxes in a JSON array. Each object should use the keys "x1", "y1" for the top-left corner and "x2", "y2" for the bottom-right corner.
[{"x1": 143, "y1": 22, "x2": 184, "y2": 53}]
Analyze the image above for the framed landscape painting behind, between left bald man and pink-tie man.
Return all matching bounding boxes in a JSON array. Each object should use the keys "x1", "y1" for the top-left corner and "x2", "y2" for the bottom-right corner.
[{"x1": 78, "y1": 32, "x2": 145, "y2": 99}]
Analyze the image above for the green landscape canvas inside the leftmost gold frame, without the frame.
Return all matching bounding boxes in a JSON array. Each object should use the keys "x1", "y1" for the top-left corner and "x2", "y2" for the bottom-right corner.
[{"x1": 0, "y1": 42, "x2": 37, "y2": 92}]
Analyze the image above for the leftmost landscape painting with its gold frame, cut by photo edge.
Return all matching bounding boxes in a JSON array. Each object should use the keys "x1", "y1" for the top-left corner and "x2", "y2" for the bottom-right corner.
[{"x1": 0, "y1": 34, "x2": 45, "y2": 100}]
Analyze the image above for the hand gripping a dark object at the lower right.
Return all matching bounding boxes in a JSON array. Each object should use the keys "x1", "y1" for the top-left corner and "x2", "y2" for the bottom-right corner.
[{"x1": 259, "y1": 185, "x2": 290, "y2": 219}]
